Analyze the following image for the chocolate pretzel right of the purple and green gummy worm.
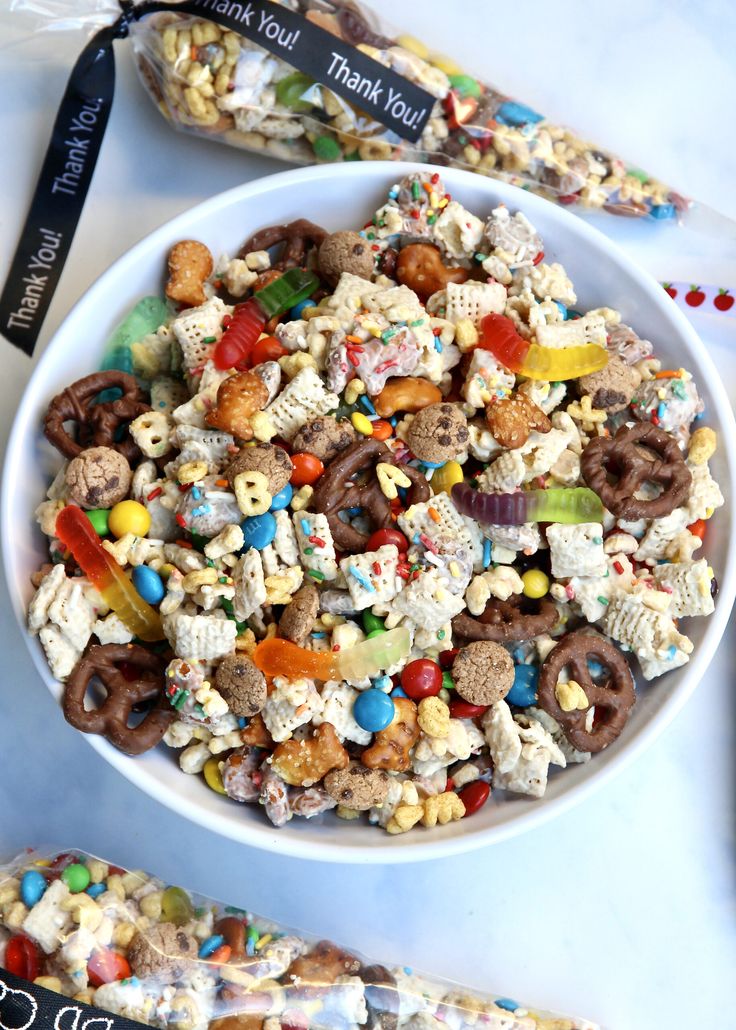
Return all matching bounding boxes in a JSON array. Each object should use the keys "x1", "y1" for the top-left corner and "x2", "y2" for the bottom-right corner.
[{"x1": 581, "y1": 422, "x2": 693, "y2": 519}]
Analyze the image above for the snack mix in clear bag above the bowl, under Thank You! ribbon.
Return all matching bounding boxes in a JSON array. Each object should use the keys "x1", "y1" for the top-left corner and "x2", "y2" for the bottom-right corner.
[{"x1": 131, "y1": 0, "x2": 690, "y2": 219}]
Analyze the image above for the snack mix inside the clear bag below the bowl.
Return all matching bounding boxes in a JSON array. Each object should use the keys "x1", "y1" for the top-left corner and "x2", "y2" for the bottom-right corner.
[{"x1": 0, "y1": 852, "x2": 596, "y2": 1030}]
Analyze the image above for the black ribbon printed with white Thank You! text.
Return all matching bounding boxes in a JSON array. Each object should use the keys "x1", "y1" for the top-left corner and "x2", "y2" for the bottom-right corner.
[{"x1": 0, "y1": 0, "x2": 434, "y2": 355}]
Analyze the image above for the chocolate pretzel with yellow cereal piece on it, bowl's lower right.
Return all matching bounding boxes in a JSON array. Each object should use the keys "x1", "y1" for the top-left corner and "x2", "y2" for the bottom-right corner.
[{"x1": 537, "y1": 630, "x2": 636, "y2": 751}]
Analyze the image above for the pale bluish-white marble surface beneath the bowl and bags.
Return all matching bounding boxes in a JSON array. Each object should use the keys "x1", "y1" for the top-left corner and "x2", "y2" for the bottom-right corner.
[{"x1": 0, "y1": 0, "x2": 736, "y2": 1030}]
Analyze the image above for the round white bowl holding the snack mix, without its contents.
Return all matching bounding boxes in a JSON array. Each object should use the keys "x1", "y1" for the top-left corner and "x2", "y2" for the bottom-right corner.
[{"x1": 1, "y1": 162, "x2": 736, "y2": 862}]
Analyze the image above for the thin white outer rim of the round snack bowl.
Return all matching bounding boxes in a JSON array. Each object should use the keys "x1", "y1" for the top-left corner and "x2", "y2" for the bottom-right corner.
[{"x1": 5, "y1": 161, "x2": 736, "y2": 864}]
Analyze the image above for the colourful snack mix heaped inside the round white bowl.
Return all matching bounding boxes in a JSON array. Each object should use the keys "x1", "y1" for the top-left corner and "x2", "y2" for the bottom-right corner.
[{"x1": 28, "y1": 169, "x2": 724, "y2": 834}]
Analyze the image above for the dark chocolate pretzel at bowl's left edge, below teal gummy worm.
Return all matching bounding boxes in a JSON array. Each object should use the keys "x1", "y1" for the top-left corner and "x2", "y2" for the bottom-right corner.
[{"x1": 43, "y1": 369, "x2": 151, "y2": 461}]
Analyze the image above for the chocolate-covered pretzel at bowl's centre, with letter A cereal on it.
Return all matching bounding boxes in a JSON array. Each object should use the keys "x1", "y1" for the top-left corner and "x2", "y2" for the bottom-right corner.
[{"x1": 312, "y1": 438, "x2": 429, "y2": 554}]
